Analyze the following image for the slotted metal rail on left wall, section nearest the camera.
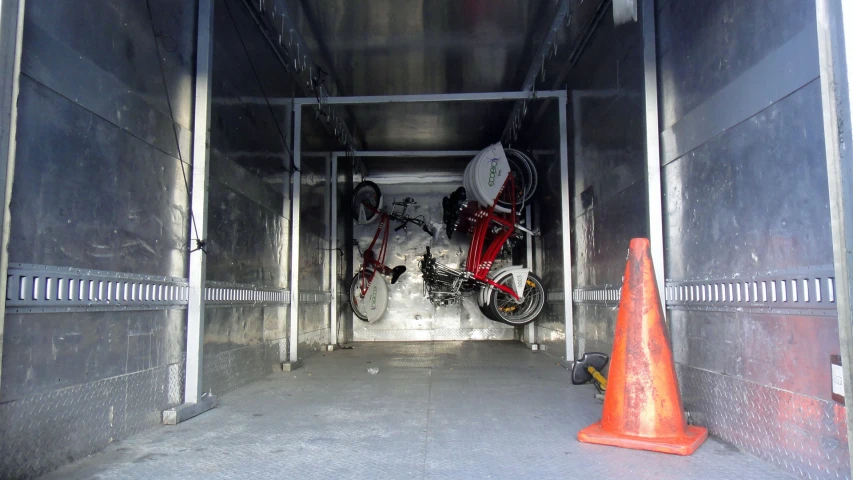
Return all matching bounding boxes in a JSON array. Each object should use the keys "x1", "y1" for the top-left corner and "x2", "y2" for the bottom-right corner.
[{"x1": 6, "y1": 263, "x2": 189, "y2": 313}]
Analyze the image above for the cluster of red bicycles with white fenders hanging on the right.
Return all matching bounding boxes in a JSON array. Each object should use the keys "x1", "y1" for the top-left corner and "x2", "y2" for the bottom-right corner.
[{"x1": 420, "y1": 144, "x2": 545, "y2": 325}]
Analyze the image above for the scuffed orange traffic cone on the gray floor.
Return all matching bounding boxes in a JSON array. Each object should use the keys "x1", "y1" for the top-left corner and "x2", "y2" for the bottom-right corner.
[{"x1": 578, "y1": 238, "x2": 708, "y2": 455}]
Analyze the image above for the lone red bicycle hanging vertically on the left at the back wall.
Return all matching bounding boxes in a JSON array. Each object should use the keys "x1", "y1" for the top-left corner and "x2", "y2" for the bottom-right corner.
[{"x1": 349, "y1": 181, "x2": 435, "y2": 323}]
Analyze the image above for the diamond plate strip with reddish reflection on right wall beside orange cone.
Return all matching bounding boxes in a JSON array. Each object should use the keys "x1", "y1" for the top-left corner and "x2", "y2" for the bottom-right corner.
[{"x1": 677, "y1": 364, "x2": 850, "y2": 479}]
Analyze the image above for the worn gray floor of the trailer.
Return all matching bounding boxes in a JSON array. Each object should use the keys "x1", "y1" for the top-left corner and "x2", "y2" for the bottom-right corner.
[{"x1": 45, "y1": 342, "x2": 791, "y2": 480}]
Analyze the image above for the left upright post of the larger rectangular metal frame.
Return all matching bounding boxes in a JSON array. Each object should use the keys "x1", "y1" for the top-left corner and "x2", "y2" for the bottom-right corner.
[{"x1": 282, "y1": 107, "x2": 302, "y2": 371}]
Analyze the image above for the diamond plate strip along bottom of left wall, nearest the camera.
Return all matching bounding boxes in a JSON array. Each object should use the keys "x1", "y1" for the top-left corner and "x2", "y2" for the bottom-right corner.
[{"x1": 0, "y1": 364, "x2": 184, "y2": 478}]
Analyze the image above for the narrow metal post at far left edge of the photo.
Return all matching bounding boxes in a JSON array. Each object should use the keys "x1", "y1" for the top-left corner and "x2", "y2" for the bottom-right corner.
[{"x1": 0, "y1": 0, "x2": 26, "y2": 394}]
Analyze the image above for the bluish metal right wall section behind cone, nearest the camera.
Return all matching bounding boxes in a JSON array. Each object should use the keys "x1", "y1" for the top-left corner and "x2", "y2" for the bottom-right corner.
[{"x1": 657, "y1": 0, "x2": 850, "y2": 478}]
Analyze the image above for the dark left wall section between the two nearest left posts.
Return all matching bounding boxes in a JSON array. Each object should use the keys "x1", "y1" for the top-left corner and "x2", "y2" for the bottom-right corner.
[{"x1": 202, "y1": 0, "x2": 294, "y2": 395}]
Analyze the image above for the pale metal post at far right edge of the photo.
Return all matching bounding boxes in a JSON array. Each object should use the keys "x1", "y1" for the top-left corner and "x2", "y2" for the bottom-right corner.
[{"x1": 817, "y1": 0, "x2": 853, "y2": 464}]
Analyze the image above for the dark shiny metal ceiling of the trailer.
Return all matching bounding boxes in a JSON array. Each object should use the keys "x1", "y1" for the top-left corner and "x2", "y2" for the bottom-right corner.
[{"x1": 287, "y1": 0, "x2": 580, "y2": 150}]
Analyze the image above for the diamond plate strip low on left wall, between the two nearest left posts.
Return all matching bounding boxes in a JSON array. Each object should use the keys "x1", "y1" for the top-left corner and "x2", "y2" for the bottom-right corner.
[{"x1": 203, "y1": 341, "x2": 279, "y2": 396}]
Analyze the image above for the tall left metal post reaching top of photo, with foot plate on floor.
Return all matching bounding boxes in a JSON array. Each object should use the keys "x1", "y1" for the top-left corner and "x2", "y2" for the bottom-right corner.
[{"x1": 163, "y1": 0, "x2": 216, "y2": 423}]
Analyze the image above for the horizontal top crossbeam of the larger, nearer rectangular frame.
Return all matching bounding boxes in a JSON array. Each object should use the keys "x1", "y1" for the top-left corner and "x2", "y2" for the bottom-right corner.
[{"x1": 292, "y1": 90, "x2": 566, "y2": 105}]
